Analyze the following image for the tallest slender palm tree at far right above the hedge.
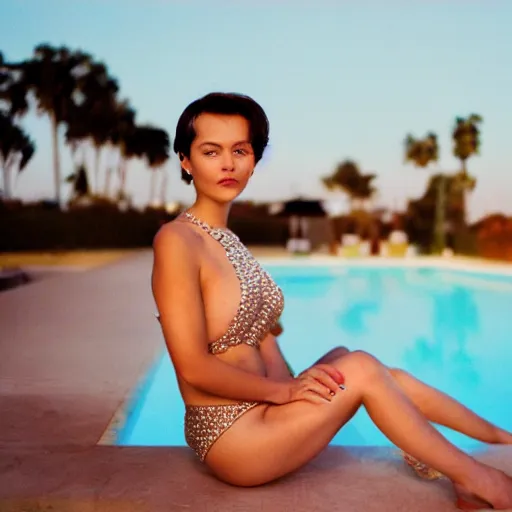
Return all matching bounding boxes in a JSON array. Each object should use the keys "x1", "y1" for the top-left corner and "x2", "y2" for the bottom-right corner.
[{"x1": 452, "y1": 114, "x2": 483, "y2": 223}]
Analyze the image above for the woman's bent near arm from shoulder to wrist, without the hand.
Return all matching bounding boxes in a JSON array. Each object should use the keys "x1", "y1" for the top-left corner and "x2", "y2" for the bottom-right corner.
[{"x1": 152, "y1": 224, "x2": 291, "y2": 403}]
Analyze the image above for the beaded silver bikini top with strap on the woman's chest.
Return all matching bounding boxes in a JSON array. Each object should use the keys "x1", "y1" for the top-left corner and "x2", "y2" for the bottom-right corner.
[{"x1": 181, "y1": 212, "x2": 284, "y2": 354}]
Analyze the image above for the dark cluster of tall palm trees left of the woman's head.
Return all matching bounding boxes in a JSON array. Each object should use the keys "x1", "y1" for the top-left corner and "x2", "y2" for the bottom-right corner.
[{"x1": 0, "y1": 44, "x2": 170, "y2": 205}]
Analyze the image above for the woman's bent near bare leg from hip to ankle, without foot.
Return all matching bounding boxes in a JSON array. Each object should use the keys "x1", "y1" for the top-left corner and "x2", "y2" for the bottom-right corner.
[{"x1": 209, "y1": 352, "x2": 512, "y2": 509}]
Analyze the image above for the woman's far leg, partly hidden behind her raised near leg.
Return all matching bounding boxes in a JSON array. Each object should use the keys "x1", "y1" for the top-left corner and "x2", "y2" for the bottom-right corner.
[{"x1": 317, "y1": 347, "x2": 512, "y2": 444}]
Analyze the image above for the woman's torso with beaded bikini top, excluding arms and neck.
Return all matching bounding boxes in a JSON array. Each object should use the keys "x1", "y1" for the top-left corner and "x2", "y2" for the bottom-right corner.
[{"x1": 171, "y1": 211, "x2": 283, "y2": 405}]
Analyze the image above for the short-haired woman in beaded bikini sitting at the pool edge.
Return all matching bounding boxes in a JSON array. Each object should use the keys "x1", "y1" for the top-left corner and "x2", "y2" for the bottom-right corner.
[{"x1": 152, "y1": 93, "x2": 512, "y2": 509}]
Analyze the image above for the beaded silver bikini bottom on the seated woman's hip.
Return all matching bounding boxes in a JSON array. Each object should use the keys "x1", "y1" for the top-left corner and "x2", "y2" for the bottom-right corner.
[{"x1": 185, "y1": 402, "x2": 259, "y2": 461}]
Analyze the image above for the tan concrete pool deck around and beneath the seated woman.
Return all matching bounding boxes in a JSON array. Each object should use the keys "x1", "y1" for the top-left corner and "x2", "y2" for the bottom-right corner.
[{"x1": 0, "y1": 248, "x2": 512, "y2": 512}]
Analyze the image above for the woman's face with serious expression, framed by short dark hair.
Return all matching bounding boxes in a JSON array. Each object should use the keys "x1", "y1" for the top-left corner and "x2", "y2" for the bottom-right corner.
[{"x1": 181, "y1": 113, "x2": 255, "y2": 203}]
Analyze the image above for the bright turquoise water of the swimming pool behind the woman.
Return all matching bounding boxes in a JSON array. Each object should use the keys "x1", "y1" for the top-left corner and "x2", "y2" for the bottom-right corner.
[{"x1": 117, "y1": 266, "x2": 512, "y2": 448}]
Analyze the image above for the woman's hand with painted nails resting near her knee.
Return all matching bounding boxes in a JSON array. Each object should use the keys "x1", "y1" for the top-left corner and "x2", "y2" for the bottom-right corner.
[{"x1": 276, "y1": 364, "x2": 344, "y2": 404}]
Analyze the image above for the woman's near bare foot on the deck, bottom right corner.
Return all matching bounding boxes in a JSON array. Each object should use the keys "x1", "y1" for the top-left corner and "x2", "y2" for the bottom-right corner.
[{"x1": 454, "y1": 468, "x2": 512, "y2": 510}]
